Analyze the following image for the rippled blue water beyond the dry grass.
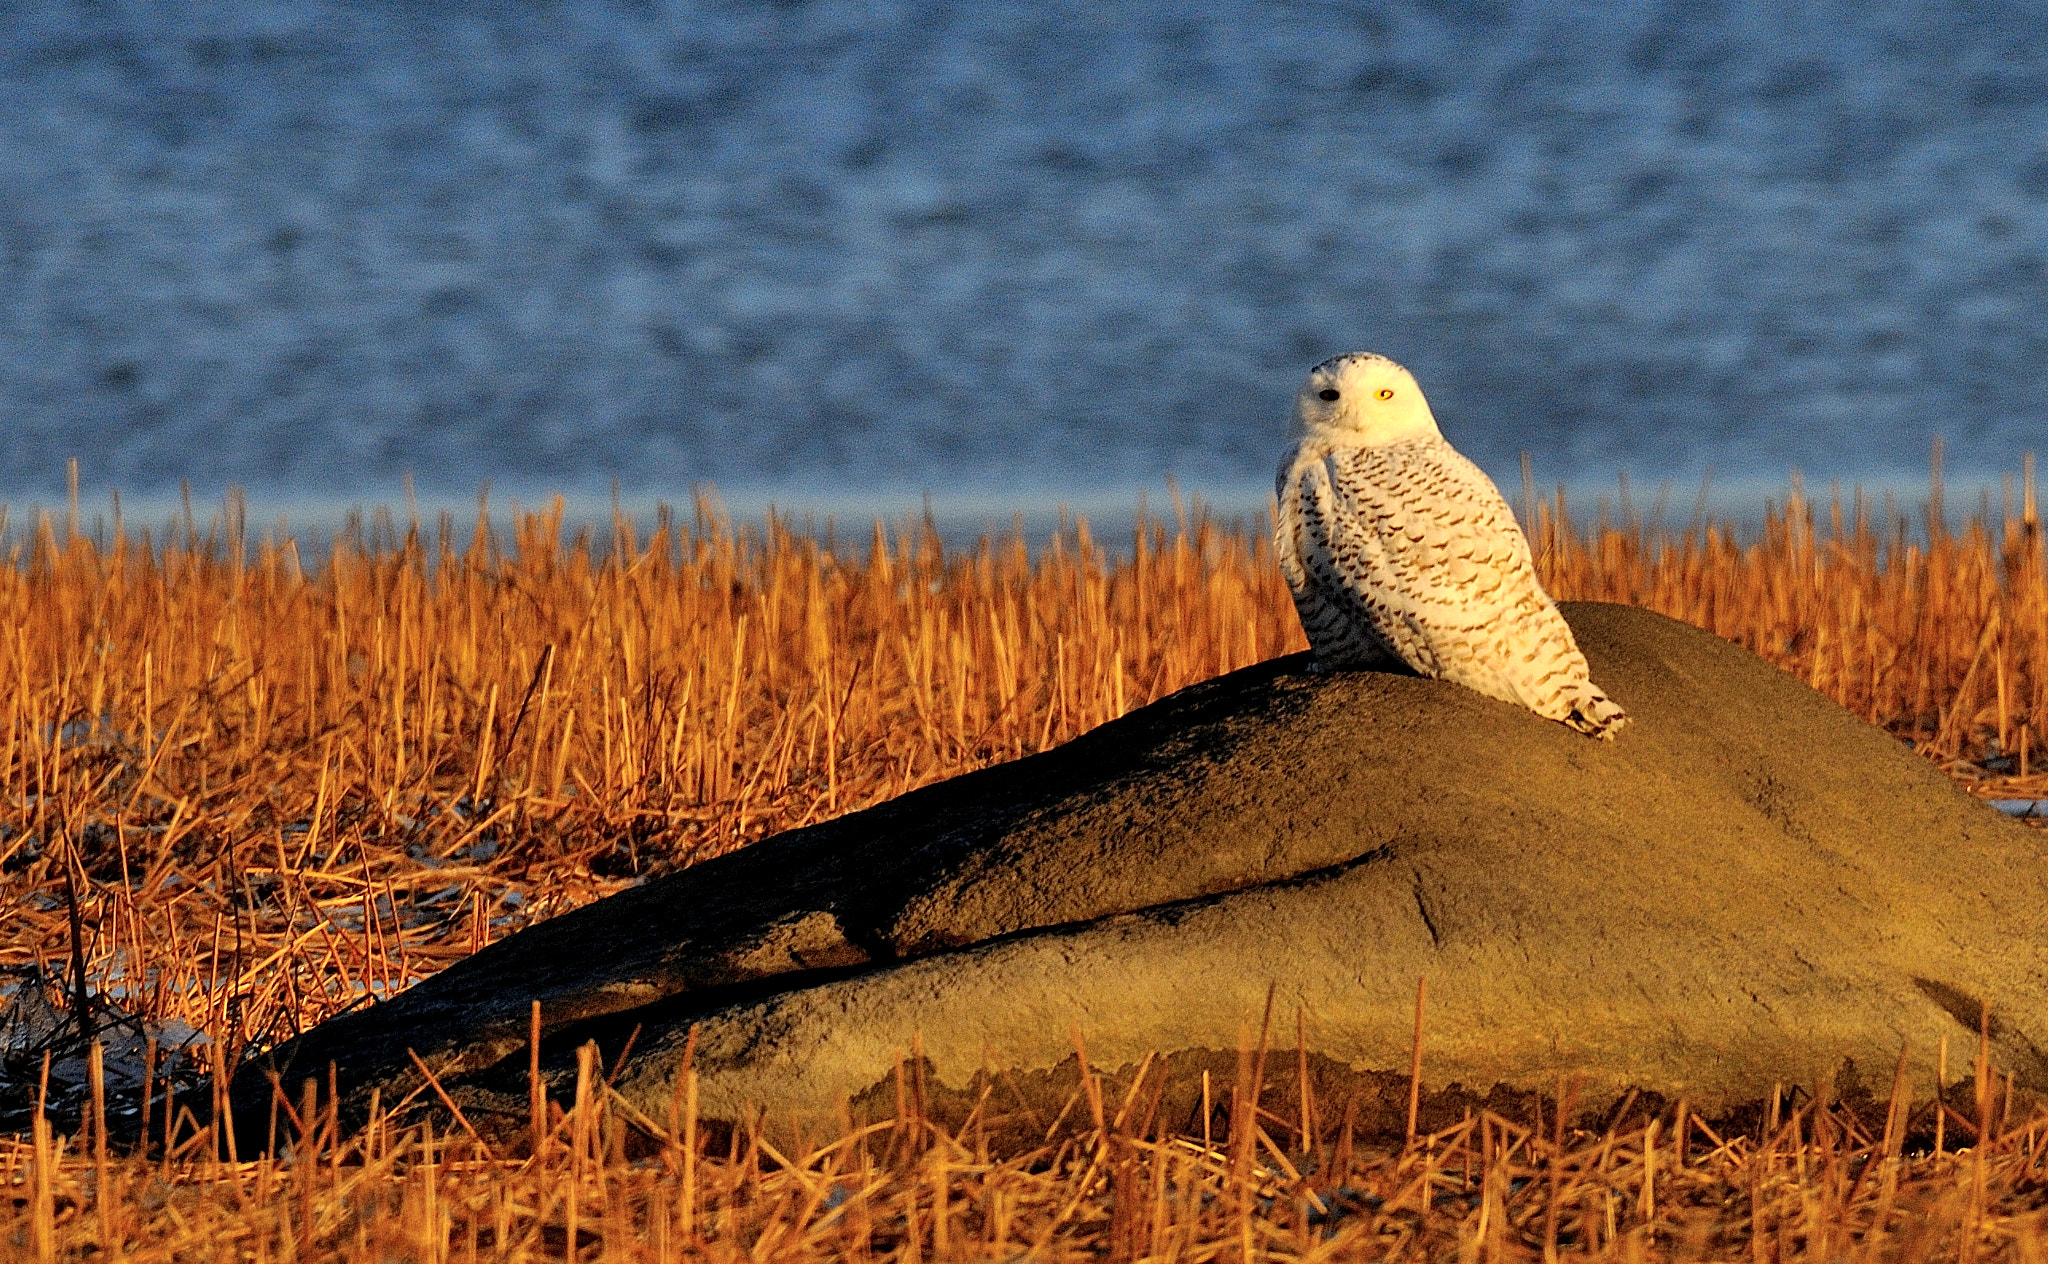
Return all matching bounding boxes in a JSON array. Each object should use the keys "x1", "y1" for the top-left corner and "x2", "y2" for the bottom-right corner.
[{"x1": 0, "y1": 0, "x2": 2048, "y2": 502}]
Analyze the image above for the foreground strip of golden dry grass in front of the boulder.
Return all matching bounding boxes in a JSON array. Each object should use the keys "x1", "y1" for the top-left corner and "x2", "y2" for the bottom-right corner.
[{"x1": 12, "y1": 1036, "x2": 2048, "y2": 1264}]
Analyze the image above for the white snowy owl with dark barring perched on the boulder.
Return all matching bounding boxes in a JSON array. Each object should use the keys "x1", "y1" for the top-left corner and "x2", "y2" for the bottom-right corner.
[{"x1": 1274, "y1": 352, "x2": 1628, "y2": 740}]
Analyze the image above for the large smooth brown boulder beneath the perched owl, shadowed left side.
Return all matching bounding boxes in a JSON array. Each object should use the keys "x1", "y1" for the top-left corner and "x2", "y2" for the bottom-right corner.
[{"x1": 238, "y1": 604, "x2": 2048, "y2": 1129}]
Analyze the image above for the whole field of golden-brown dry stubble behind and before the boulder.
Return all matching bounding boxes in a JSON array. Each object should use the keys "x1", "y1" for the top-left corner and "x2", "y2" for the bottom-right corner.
[{"x1": 0, "y1": 463, "x2": 2048, "y2": 1262}]
